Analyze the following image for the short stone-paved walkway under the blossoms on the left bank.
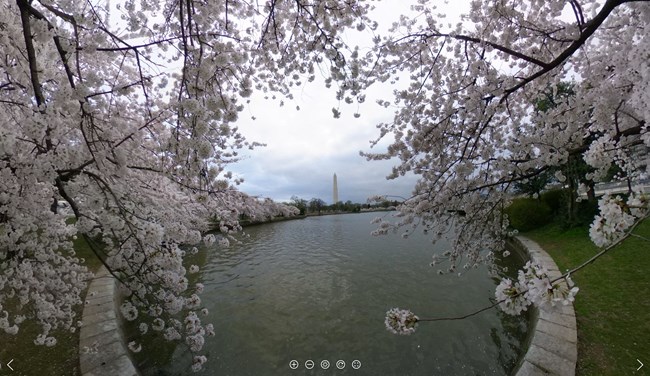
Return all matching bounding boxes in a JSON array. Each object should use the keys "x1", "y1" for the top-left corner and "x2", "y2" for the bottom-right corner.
[{"x1": 79, "y1": 266, "x2": 138, "y2": 376}]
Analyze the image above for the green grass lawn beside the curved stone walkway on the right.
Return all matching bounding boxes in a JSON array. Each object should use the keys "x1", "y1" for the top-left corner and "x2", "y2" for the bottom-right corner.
[{"x1": 524, "y1": 220, "x2": 650, "y2": 376}]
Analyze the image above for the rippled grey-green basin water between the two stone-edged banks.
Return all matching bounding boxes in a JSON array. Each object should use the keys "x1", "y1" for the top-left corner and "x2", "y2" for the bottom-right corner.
[{"x1": 138, "y1": 213, "x2": 528, "y2": 376}]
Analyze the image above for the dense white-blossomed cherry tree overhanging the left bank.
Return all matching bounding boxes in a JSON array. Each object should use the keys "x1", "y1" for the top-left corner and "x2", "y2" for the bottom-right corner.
[{"x1": 0, "y1": 0, "x2": 370, "y2": 369}]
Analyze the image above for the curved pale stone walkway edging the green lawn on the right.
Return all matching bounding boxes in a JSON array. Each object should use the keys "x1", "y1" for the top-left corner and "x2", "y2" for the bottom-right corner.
[{"x1": 514, "y1": 236, "x2": 578, "y2": 376}]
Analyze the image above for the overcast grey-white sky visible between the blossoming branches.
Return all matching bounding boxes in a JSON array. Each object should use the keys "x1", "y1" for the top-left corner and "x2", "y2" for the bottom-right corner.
[{"x1": 230, "y1": 0, "x2": 467, "y2": 204}]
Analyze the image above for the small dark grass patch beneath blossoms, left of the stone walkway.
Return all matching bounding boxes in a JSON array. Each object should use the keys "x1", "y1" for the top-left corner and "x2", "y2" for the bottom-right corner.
[{"x1": 0, "y1": 237, "x2": 100, "y2": 375}]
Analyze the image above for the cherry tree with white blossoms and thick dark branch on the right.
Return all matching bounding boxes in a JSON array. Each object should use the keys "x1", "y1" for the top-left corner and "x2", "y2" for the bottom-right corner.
[{"x1": 352, "y1": 0, "x2": 650, "y2": 330}]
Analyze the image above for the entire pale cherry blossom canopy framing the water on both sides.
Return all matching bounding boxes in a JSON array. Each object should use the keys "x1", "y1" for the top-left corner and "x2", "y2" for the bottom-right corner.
[{"x1": 0, "y1": 0, "x2": 650, "y2": 369}]
